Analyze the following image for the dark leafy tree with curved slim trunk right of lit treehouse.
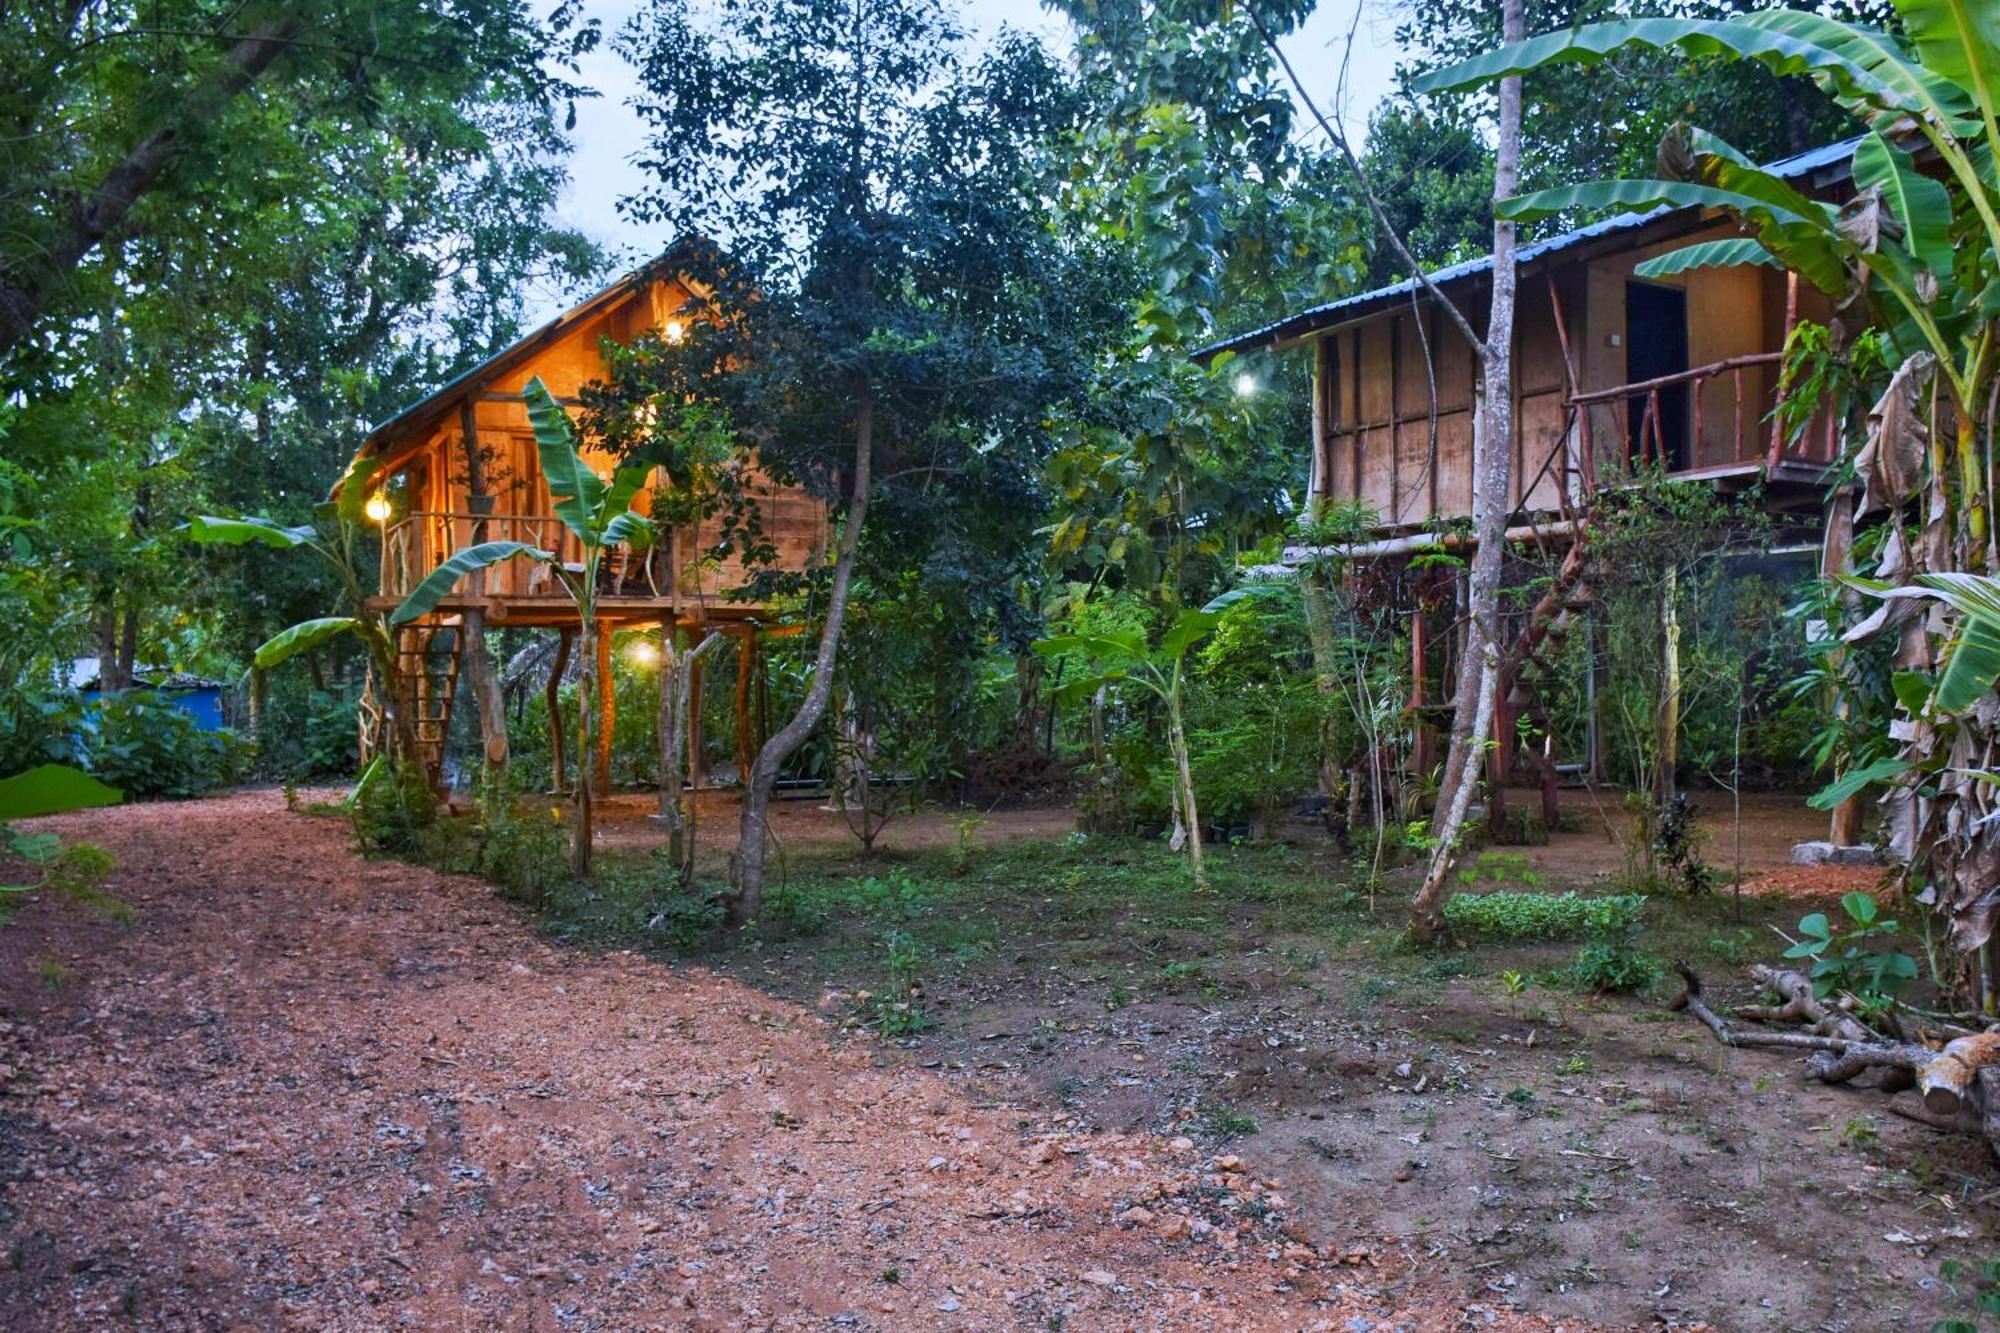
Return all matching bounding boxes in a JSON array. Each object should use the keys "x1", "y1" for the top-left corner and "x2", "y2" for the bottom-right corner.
[{"x1": 620, "y1": 0, "x2": 1096, "y2": 923}]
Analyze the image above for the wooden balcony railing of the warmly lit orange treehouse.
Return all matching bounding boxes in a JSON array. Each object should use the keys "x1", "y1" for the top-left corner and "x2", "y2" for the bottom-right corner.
[{"x1": 382, "y1": 512, "x2": 664, "y2": 598}]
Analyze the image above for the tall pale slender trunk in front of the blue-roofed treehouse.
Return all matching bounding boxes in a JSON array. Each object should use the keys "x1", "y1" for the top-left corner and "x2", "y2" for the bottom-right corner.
[{"x1": 1410, "y1": 0, "x2": 1526, "y2": 941}]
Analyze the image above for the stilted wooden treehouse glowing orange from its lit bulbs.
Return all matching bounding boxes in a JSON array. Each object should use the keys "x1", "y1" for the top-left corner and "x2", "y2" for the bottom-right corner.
[{"x1": 344, "y1": 248, "x2": 828, "y2": 791}]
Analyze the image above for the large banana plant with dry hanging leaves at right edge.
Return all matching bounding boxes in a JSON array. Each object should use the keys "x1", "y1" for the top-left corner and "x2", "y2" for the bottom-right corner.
[{"x1": 1416, "y1": 0, "x2": 2000, "y2": 972}]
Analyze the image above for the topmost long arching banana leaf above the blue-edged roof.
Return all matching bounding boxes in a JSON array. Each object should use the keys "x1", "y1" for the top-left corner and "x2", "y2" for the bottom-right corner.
[{"x1": 1414, "y1": 18, "x2": 1906, "y2": 106}]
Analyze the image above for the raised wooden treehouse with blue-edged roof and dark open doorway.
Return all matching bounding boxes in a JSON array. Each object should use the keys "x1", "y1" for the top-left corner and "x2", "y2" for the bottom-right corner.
[{"x1": 1196, "y1": 142, "x2": 1854, "y2": 843}]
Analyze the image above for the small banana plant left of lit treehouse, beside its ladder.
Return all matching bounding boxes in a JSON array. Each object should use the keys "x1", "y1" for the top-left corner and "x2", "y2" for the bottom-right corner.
[{"x1": 184, "y1": 446, "x2": 418, "y2": 765}]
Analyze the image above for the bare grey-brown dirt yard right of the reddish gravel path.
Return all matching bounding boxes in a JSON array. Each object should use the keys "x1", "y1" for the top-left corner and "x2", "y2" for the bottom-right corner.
[{"x1": 568, "y1": 797, "x2": 2000, "y2": 1333}]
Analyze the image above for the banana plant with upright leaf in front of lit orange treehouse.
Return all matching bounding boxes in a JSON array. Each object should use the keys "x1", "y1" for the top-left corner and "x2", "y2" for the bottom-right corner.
[{"x1": 388, "y1": 376, "x2": 654, "y2": 875}]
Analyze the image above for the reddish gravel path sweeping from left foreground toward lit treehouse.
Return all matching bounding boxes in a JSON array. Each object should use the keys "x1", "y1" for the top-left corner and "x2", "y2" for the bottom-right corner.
[{"x1": 0, "y1": 793, "x2": 1600, "y2": 1333}]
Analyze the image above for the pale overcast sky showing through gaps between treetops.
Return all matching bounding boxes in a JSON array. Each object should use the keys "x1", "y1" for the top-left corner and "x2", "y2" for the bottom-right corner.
[{"x1": 532, "y1": 0, "x2": 1396, "y2": 320}]
